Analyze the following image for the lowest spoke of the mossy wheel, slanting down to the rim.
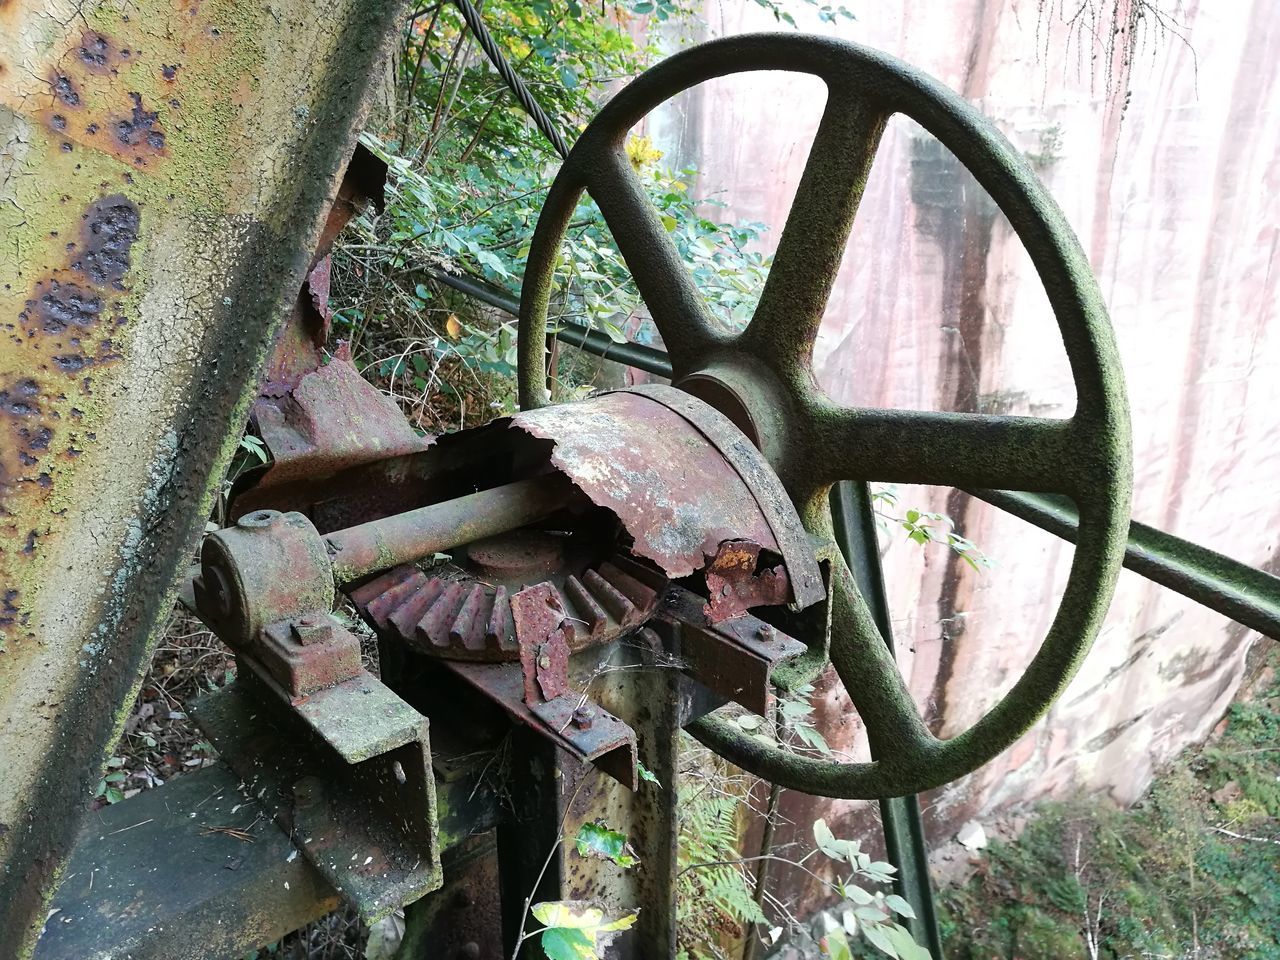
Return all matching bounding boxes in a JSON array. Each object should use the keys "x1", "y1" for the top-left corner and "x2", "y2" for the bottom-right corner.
[{"x1": 831, "y1": 552, "x2": 933, "y2": 765}]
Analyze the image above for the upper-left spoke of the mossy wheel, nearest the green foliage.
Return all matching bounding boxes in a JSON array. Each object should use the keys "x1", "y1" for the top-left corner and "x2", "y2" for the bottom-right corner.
[{"x1": 585, "y1": 147, "x2": 722, "y2": 376}]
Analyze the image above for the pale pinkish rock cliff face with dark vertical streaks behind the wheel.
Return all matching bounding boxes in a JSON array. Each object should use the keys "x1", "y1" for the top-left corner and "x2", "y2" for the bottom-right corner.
[{"x1": 649, "y1": 0, "x2": 1280, "y2": 840}]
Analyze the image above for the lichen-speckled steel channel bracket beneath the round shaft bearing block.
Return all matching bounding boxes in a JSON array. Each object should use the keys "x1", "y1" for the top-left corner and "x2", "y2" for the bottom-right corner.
[{"x1": 192, "y1": 654, "x2": 443, "y2": 923}]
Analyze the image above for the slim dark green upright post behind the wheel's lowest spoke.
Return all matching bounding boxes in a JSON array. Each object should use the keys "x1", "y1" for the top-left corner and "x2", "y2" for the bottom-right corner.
[{"x1": 831, "y1": 480, "x2": 942, "y2": 960}]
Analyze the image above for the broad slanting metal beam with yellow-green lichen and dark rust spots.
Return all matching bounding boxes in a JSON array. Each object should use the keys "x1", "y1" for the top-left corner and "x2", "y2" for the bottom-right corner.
[{"x1": 0, "y1": 0, "x2": 399, "y2": 954}]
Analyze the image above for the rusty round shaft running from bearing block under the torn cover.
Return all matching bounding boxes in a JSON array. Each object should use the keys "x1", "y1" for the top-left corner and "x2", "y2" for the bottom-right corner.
[{"x1": 323, "y1": 474, "x2": 573, "y2": 584}]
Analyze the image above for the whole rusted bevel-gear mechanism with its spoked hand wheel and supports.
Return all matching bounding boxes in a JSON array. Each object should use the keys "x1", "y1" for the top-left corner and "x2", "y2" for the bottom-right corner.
[{"x1": 5, "y1": 18, "x2": 1280, "y2": 957}]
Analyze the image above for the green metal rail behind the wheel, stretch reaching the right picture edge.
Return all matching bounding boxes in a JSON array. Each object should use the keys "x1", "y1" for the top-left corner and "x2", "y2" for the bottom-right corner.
[{"x1": 968, "y1": 490, "x2": 1280, "y2": 640}]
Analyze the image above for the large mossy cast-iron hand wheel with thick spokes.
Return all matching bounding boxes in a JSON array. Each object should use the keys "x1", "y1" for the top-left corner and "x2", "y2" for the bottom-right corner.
[{"x1": 520, "y1": 33, "x2": 1132, "y2": 799}]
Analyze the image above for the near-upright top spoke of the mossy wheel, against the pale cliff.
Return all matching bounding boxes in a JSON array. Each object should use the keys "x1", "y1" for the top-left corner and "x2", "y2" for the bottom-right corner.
[{"x1": 744, "y1": 88, "x2": 888, "y2": 376}]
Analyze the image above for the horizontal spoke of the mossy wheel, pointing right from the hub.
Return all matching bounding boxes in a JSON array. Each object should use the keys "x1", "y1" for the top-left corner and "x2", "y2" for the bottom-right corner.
[{"x1": 809, "y1": 406, "x2": 1080, "y2": 494}]
